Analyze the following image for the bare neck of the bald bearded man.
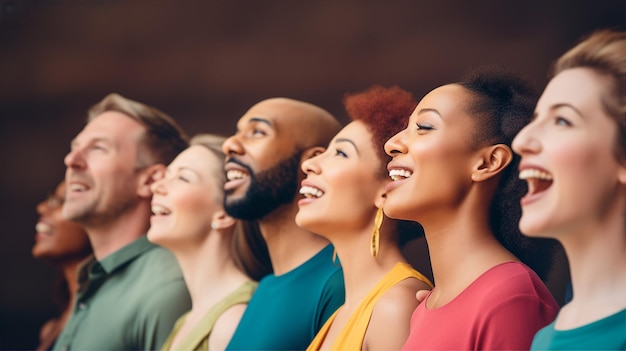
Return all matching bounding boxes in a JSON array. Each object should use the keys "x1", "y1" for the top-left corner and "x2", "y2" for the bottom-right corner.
[{"x1": 259, "y1": 206, "x2": 328, "y2": 275}]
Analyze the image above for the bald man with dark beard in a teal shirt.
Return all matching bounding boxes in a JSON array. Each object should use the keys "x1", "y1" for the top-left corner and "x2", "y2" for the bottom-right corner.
[{"x1": 223, "y1": 98, "x2": 344, "y2": 350}]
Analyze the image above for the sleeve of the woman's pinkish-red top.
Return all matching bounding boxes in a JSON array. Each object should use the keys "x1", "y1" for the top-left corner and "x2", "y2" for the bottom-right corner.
[{"x1": 475, "y1": 295, "x2": 556, "y2": 350}]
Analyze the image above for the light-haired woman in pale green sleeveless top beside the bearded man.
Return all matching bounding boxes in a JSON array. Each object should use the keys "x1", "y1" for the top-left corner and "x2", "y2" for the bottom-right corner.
[{"x1": 148, "y1": 134, "x2": 271, "y2": 350}]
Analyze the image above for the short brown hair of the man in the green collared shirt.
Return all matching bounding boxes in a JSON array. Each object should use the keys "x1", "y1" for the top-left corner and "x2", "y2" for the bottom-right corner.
[{"x1": 87, "y1": 93, "x2": 189, "y2": 168}]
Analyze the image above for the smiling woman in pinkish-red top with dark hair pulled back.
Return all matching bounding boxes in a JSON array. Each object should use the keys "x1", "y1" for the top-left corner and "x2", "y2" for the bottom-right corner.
[{"x1": 384, "y1": 69, "x2": 558, "y2": 350}]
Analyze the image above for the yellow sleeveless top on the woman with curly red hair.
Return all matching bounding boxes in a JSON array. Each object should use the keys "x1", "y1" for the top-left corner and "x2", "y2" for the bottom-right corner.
[{"x1": 307, "y1": 262, "x2": 433, "y2": 351}]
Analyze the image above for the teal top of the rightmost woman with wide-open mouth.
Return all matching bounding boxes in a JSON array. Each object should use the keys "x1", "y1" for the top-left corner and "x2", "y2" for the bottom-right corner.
[{"x1": 530, "y1": 309, "x2": 626, "y2": 350}]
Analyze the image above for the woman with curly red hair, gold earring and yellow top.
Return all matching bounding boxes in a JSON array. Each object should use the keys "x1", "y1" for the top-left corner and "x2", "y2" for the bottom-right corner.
[{"x1": 296, "y1": 86, "x2": 432, "y2": 350}]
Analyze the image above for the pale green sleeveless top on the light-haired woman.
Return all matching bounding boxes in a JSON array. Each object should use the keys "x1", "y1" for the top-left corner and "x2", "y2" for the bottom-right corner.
[{"x1": 161, "y1": 281, "x2": 257, "y2": 351}]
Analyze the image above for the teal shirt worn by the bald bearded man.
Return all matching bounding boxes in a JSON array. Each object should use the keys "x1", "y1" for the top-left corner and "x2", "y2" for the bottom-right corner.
[{"x1": 227, "y1": 245, "x2": 345, "y2": 350}]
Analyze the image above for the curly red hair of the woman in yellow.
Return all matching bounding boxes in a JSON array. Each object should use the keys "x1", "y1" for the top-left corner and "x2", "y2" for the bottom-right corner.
[{"x1": 343, "y1": 85, "x2": 417, "y2": 177}]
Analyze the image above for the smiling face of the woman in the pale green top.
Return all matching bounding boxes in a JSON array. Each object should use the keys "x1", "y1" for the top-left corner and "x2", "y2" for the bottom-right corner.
[{"x1": 148, "y1": 145, "x2": 222, "y2": 251}]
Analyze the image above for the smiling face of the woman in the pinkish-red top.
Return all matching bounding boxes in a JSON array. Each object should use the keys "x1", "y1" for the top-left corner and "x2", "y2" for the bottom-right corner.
[{"x1": 384, "y1": 84, "x2": 480, "y2": 221}]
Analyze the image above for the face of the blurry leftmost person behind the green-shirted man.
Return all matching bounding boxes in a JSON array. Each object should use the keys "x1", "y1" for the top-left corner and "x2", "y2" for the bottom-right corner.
[{"x1": 32, "y1": 182, "x2": 91, "y2": 263}]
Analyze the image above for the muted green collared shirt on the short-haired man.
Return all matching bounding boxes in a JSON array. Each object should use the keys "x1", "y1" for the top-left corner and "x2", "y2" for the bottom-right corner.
[{"x1": 54, "y1": 236, "x2": 191, "y2": 351}]
